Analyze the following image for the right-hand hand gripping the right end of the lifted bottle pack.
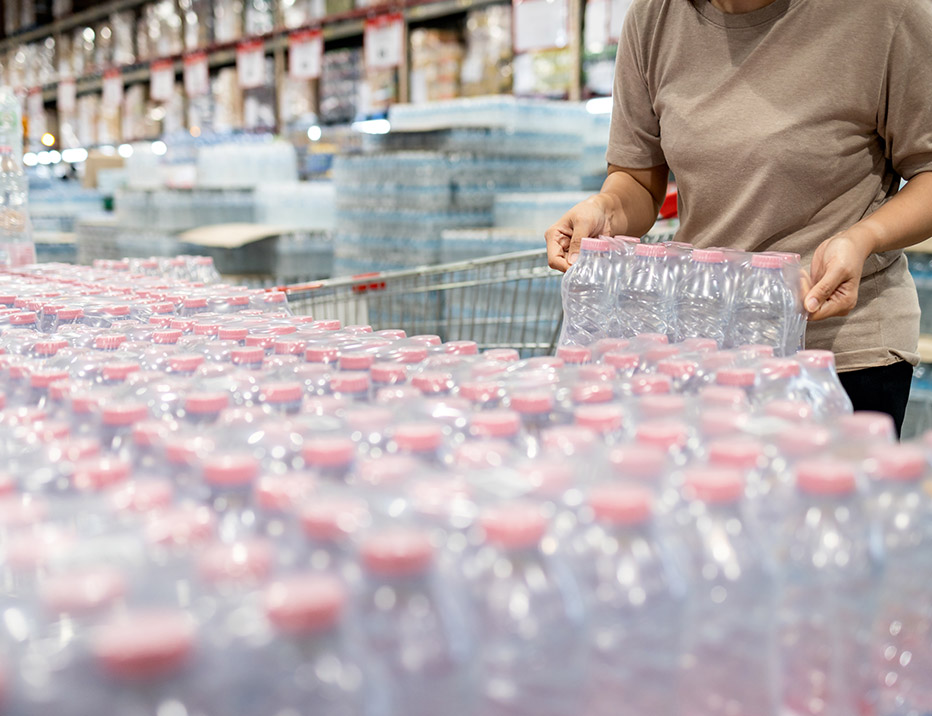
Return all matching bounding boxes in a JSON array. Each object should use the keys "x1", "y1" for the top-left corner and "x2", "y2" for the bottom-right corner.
[{"x1": 804, "y1": 233, "x2": 871, "y2": 321}]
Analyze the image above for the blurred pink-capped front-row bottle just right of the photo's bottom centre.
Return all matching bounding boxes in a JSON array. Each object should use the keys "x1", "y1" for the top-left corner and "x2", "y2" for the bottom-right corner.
[{"x1": 463, "y1": 503, "x2": 586, "y2": 716}]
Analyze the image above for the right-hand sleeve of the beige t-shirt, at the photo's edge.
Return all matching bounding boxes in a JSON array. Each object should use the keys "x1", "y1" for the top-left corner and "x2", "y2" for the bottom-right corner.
[{"x1": 878, "y1": 0, "x2": 932, "y2": 180}]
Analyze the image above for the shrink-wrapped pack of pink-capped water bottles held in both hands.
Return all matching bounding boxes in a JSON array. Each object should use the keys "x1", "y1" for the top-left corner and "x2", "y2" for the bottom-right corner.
[{"x1": 560, "y1": 236, "x2": 808, "y2": 356}]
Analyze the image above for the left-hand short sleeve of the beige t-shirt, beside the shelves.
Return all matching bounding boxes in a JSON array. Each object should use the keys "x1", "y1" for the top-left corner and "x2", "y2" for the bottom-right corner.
[{"x1": 606, "y1": 9, "x2": 665, "y2": 169}]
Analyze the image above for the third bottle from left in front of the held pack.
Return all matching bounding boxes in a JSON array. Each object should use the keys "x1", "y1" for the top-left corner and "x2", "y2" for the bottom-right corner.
[{"x1": 674, "y1": 249, "x2": 731, "y2": 346}]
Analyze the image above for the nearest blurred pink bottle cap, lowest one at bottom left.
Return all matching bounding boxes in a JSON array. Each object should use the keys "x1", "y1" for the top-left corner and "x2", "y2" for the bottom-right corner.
[{"x1": 91, "y1": 610, "x2": 195, "y2": 681}]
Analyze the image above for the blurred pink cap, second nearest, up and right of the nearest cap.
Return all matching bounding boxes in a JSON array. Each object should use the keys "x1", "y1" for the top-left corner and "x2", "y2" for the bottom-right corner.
[{"x1": 264, "y1": 574, "x2": 347, "y2": 634}]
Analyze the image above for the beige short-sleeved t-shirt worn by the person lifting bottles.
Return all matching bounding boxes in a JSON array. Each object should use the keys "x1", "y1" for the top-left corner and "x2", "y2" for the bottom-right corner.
[{"x1": 607, "y1": 0, "x2": 932, "y2": 370}]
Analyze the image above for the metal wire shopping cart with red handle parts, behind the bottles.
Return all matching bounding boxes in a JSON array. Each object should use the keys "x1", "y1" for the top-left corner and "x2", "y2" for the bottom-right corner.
[{"x1": 280, "y1": 249, "x2": 563, "y2": 356}]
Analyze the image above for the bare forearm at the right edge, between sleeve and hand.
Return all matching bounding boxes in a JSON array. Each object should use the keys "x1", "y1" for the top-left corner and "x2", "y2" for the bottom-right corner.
[{"x1": 844, "y1": 172, "x2": 932, "y2": 254}]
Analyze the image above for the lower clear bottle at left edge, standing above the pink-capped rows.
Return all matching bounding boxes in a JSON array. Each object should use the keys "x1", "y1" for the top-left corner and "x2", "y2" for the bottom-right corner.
[{"x1": 0, "y1": 146, "x2": 36, "y2": 268}]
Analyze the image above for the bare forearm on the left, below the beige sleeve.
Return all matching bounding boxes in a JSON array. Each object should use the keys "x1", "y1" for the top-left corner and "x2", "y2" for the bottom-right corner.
[{"x1": 594, "y1": 167, "x2": 668, "y2": 236}]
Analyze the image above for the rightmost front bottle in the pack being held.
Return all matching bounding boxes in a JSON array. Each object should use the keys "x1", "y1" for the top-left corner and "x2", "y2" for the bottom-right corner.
[{"x1": 729, "y1": 253, "x2": 805, "y2": 356}]
